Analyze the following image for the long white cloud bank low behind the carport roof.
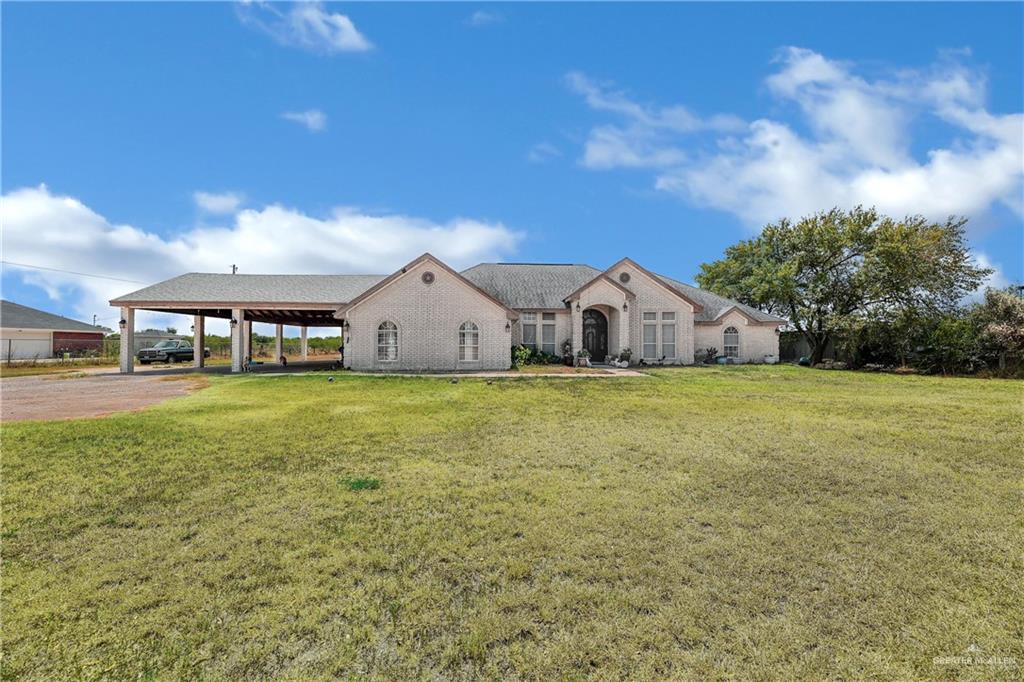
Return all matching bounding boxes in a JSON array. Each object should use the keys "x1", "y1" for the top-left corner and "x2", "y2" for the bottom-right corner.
[{"x1": 0, "y1": 186, "x2": 522, "y2": 333}]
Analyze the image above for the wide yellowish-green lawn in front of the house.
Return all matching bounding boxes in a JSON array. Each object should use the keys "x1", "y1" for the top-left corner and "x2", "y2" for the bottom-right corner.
[{"x1": 2, "y1": 367, "x2": 1024, "y2": 680}]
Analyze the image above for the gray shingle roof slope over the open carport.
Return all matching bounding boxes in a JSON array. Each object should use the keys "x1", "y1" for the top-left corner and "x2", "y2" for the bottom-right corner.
[{"x1": 111, "y1": 272, "x2": 385, "y2": 305}]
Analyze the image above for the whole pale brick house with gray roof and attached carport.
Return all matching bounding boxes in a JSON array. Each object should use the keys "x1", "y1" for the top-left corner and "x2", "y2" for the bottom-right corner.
[{"x1": 111, "y1": 254, "x2": 785, "y2": 372}]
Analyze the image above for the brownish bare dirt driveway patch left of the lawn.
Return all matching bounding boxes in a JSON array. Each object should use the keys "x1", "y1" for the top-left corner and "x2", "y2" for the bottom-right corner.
[{"x1": 0, "y1": 373, "x2": 209, "y2": 423}]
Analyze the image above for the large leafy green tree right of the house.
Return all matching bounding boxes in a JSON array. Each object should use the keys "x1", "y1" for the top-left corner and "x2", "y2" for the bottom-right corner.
[{"x1": 697, "y1": 207, "x2": 990, "y2": 363}]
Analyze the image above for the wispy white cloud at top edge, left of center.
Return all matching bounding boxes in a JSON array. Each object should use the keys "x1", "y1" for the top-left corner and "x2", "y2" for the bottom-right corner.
[{"x1": 238, "y1": 2, "x2": 374, "y2": 54}]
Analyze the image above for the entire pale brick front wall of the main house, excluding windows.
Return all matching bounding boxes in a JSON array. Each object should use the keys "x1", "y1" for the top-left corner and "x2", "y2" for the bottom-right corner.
[{"x1": 337, "y1": 254, "x2": 779, "y2": 371}]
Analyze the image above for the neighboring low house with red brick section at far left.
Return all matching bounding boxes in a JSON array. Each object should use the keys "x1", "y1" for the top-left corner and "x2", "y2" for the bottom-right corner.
[{"x1": 0, "y1": 301, "x2": 110, "y2": 363}]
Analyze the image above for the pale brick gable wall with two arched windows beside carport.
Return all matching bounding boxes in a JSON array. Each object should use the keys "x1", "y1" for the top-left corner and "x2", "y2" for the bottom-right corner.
[{"x1": 345, "y1": 260, "x2": 512, "y2": 371}]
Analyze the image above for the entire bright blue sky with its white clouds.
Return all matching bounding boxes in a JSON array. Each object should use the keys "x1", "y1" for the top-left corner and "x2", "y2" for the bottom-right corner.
[{"x1": 2, "y1": 3, "x2": 1024, "y2": 331}]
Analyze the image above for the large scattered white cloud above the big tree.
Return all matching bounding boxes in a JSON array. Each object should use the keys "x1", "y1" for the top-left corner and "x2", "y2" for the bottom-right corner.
[{"x1": 569, "y1": 47, "x2": 1024, "y2": 227}]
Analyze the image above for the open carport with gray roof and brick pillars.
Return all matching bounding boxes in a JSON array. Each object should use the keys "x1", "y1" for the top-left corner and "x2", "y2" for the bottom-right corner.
[{"x1": 111, "y1": 272, "x2": 384, "y2": 374}]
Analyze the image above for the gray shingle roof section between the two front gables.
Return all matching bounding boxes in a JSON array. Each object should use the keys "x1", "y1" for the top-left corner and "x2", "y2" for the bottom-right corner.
[{"x1": 461, "y1": 263, "x2": 601, "y2": 308}]
